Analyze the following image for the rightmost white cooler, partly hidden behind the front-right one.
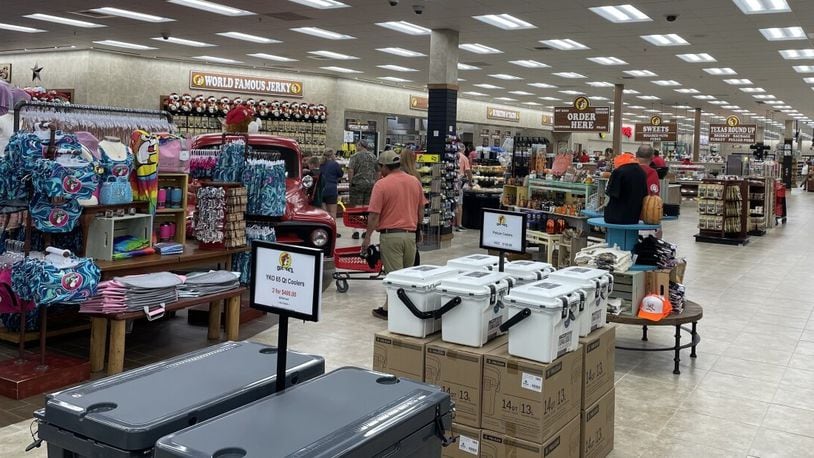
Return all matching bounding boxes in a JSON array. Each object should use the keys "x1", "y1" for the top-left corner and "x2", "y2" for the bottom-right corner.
[{"x1": 549, "y1": 266, "x2": 613, "y2": 337}]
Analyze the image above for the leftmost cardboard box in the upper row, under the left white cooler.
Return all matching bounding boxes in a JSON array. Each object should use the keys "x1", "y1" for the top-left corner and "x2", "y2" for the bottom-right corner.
[{"x1": 373, "y1": 331, "x2": 441, "y2": 382}]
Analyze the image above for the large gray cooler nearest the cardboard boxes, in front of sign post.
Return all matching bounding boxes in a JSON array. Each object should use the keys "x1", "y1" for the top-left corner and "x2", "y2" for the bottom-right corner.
[{"x1": 155, "y1": 367, "x2": 452, "y2": 458}]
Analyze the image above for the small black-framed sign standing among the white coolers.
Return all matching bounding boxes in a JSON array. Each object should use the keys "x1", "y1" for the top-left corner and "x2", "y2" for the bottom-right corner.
[{"x1": 480, "y1": 208, "x2": 527, "y2": 272}]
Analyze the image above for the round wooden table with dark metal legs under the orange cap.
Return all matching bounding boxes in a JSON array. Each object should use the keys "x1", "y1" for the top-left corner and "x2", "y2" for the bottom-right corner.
[{"x1": 608, "y1": 301, "x2": 704, "y2": 374}]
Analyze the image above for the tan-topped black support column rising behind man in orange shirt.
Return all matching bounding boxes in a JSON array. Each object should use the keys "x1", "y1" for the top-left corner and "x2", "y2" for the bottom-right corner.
[{"x1": 427, "y1": 29, "x2": 459, "y2": 154}]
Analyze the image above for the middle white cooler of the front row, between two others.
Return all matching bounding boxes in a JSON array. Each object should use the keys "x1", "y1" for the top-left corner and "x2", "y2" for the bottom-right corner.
[{"x1": 437, "y1": 271, "x2": 513, "y2": 347}]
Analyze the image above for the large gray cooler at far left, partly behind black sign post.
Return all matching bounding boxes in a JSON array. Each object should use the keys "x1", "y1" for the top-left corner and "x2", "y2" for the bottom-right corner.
[{"x1": 35, "y1": 341, "x2": 325, "y2": 458}]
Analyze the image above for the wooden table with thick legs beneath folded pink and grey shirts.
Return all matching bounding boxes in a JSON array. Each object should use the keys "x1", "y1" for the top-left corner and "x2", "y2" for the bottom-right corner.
[{"x1": 89, "y1": 286, "x2": 246, "y2": 375}]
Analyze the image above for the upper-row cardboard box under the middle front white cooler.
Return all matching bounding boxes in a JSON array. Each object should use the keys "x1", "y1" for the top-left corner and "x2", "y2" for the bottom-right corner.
[{"x1": 424, "y1": 336, "x2": 509, "y2": 428}]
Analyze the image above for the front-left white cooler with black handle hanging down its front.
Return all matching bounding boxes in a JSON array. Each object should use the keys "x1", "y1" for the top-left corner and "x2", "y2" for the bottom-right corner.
[{"x1": 384, "y1": 265, "x2": 458, "y2": 338}]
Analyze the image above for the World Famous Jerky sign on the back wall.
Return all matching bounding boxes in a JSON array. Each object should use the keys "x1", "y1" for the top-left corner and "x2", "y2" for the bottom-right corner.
[{"x1": 189, "y1": 70, "x2": 302, "y2": 97}]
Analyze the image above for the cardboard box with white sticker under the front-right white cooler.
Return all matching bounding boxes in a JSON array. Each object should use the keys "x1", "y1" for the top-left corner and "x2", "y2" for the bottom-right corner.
[{"x1": 481, "y1": 346, "x2": 582, "y2": 444}]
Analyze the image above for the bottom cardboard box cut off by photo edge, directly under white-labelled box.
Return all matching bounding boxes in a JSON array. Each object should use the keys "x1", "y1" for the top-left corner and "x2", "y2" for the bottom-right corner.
[{"x1": 480, "y1": 415, "x2": 582, "y2": 458}]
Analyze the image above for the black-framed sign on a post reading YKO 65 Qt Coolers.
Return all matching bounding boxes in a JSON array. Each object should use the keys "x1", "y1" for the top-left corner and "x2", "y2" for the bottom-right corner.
[{"x1": 249, "y1": 241, "x2": 322, "y2": 392}]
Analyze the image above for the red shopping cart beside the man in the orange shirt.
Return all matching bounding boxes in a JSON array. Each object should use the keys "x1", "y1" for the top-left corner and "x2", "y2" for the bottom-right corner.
[{"x1": 333, "y1": 205, "x2": 382, "y2": 293}]
